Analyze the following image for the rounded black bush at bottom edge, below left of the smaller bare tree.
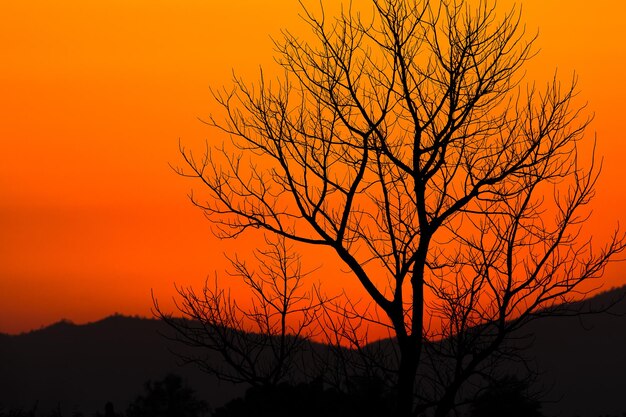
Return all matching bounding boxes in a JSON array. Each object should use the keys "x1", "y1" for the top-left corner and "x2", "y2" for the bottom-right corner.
[{"x1": 126, "y1": 374, "x2": 208, "y2": 417}]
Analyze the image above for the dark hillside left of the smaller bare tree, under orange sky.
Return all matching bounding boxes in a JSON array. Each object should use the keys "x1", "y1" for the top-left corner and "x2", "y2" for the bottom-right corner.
[{"x1": 0, "y1": 316, "x2": 242, "y2": 414}]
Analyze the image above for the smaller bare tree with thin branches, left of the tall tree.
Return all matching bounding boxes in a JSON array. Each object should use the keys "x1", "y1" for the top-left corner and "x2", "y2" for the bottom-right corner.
[{"x1": 153, "y1": 238, "x2": 321, "y2": 386}]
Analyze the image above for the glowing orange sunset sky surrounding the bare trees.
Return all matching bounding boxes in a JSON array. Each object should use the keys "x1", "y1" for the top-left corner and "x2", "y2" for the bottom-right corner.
[{"x1": 0, "y1": 0, "x2": 626, "y2": 333}]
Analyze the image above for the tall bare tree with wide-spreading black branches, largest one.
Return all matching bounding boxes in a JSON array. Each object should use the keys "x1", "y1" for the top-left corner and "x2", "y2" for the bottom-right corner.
[{"x1": 172, "y1": 0, "x2": 624, "y2": 416}]
